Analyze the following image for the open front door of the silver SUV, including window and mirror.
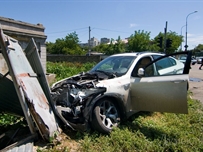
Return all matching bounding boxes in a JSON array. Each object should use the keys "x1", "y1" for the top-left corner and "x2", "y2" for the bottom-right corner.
[{"x1": 130, "y1": 51, "x2": 190, "y2": 113}]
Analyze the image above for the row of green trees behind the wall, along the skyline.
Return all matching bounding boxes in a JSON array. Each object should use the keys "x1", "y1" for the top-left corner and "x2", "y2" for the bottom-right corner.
[{"x1": 47, "y1": 30, "x2": 189, "y2": 55}]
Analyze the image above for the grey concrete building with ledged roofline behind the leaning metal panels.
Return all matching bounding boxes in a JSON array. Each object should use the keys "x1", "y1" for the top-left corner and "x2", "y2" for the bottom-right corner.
[{"x1": 0, "y1": 17, "x2": 47, "y2": 72}]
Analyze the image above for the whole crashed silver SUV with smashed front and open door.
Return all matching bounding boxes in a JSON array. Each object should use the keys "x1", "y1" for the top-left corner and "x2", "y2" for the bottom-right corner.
[{"x1": 51, "y1": 52, "x2": 190, "y2": 133}]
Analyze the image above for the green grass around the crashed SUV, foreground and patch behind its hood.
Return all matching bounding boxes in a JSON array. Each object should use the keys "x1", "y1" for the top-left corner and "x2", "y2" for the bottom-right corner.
[{"x1": 0, "y1": 63, "x2": 203, "y2": 152}]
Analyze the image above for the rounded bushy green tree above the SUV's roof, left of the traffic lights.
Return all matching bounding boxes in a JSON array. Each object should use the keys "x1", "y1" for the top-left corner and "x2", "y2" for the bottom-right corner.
[{"x1": 128, "y1": 30, "x2": 151, "y2": 52}]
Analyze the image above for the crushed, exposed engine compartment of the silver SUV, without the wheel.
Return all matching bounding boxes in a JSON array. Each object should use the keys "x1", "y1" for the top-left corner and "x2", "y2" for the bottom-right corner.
[{"x1": 51, "y1": 73, "x2": 106, "y2": 130}]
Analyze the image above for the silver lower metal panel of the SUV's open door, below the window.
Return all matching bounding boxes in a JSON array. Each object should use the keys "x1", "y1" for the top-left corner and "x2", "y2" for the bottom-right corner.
[{"x1": 130, "y1": 75, "x2": 188, "y2": 113}]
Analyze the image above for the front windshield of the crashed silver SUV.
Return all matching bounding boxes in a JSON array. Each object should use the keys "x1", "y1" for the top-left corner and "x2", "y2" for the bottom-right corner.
[{"x1": 90, "y1": 56, "x2": 136, "y2": 76}]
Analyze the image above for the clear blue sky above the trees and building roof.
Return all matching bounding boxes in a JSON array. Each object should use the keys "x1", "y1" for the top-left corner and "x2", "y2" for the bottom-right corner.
[{"x1": 0, "y1": 0, "x2": 203, "y2": 49}]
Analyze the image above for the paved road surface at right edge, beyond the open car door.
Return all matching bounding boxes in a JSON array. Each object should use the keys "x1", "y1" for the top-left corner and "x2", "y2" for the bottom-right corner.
[{"x1": 189, "y1": 64, "x2": 203, "y2": 104}]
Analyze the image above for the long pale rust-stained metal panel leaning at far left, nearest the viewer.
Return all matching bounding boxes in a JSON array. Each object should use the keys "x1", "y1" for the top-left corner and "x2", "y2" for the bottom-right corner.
[{"x1": 0, "y1": 30, "x2": 59, "y2": 140}]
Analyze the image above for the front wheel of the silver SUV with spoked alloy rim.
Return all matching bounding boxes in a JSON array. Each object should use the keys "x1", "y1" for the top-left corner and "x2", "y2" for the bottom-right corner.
[{"x1": 91, "y1": 99, "x2": 121, "y2": 133}]
